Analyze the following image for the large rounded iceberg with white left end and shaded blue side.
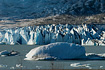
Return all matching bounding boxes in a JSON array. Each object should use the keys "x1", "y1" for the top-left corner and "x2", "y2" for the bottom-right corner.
[{"x1": 26, "y1": 42, "x2": 86, "y2": 60}]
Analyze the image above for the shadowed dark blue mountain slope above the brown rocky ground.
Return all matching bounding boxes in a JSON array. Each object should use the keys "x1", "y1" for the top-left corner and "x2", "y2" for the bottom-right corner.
[{"x1": 0, "y1": 0, "x2": 105, "y2": 19}]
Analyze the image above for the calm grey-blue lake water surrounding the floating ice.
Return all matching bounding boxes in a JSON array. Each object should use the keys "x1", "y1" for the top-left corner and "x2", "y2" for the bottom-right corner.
[{"x1": 0, "y1": 45, "x2": 105, "y2": 70}]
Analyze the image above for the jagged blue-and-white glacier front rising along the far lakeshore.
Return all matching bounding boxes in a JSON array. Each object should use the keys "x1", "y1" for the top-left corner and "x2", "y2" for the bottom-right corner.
[{"x1": 0, "y1": 24, "x2": 105, "y2": 46}]
